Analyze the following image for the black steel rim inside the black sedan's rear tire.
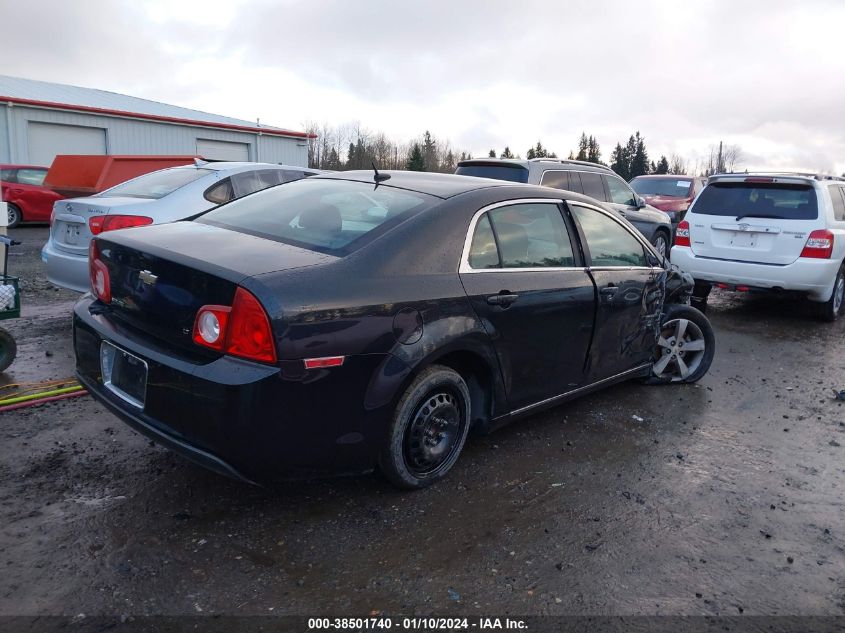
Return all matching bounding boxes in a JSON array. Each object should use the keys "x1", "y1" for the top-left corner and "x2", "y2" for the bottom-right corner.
[{"x1": 403, "y1": 387, "x2": 466, "y2": 477}]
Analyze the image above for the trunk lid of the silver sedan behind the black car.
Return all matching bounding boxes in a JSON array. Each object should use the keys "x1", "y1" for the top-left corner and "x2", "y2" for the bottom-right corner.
[{"x1": 50, "y1": 198, "x2": 155, "y2": 255}]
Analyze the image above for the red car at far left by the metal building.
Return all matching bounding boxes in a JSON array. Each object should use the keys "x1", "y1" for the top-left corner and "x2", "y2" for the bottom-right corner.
[{"x1": 0, "y1": 165, "x2": 64, "y2": 228}]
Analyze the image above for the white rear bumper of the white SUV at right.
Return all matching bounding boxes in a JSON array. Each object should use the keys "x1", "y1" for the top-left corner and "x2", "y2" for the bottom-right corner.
[{"x1": 670, "y1": 246, "x2": 842, "y2": 301}]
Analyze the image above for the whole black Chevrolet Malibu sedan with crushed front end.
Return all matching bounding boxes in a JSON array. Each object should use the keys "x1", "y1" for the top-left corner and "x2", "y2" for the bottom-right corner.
[{"x1": 74, "y1": 172, "x2": 715, "y2": 488}]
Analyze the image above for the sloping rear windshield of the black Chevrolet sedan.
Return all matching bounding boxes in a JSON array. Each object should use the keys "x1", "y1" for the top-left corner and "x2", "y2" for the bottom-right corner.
[{"x1": 197, "y1": 179, "x2": 438, "y2": 255}]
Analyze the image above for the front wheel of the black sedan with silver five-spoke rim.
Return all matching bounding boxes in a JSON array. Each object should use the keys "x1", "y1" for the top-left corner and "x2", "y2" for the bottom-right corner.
[{"x1": 648, "y1": 304, "x2": 716, "y2": 384}]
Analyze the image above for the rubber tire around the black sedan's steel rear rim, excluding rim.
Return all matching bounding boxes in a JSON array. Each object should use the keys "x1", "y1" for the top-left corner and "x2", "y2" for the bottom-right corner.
[{"x1": 379, "y1": 365, "x2": 472, "y2": 489}]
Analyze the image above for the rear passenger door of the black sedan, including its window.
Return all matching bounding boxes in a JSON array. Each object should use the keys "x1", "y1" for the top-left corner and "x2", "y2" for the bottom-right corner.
[{"x1": 460, "y1": 200, "x2": 595, "y2": 409}]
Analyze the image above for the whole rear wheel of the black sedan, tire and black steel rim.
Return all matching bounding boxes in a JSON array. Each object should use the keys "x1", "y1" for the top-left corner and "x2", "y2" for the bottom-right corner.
[{"x1": 379, "y1": 365, "x2": 471, "y2": 490}]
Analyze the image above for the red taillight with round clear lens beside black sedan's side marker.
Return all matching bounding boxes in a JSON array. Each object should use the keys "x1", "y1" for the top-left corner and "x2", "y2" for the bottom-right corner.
[{"x1": 193, "y1": 287, "x2": 276, "y2": 363}]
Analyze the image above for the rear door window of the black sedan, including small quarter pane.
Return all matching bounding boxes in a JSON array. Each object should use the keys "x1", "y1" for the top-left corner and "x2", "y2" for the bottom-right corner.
[{"x1": 469, "y1": 203, "x2": 575, "y2": 269}]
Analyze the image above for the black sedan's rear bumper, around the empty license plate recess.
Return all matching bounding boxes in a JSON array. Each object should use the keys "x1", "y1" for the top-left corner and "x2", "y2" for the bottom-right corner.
[{"x1": 74, "y1": 295, "x2": 398, "y2": 482}]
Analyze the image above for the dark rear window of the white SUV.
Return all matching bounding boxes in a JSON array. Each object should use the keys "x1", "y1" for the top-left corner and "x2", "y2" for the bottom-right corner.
[{"x1": 693, "y1": 182, "x2": 819, "y2": 220}]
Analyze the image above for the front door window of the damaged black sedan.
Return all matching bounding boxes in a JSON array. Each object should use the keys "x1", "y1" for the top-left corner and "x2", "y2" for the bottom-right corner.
[{"x1": 569, "y1": 204, "x2": 648, "y2": 268}]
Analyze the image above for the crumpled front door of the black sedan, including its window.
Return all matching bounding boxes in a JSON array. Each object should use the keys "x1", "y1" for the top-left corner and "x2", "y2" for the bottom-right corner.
[{"x1": 567, "y1": 202, "x2": 664, "y2": 382}]
